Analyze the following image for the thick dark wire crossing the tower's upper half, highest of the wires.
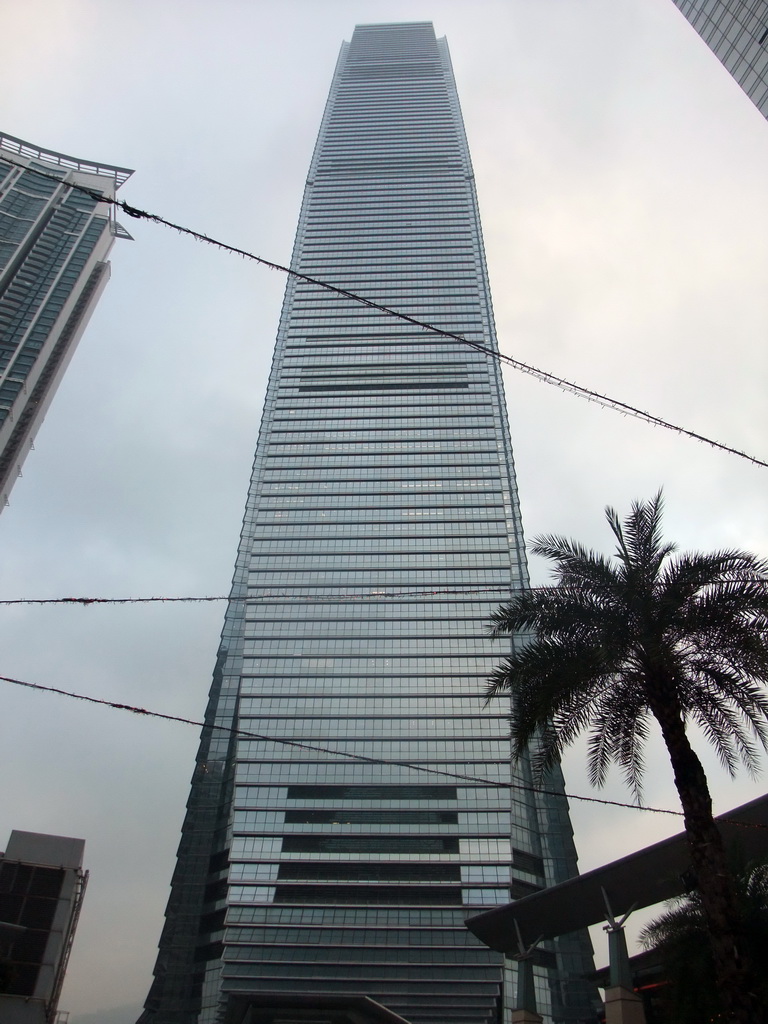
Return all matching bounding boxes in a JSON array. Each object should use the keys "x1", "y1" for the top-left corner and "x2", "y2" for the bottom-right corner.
[{"x1": 30, "y1": 169, "x2": 768, "y2": 469}]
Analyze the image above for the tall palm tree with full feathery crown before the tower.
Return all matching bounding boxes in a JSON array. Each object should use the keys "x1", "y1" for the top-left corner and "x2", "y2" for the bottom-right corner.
[{"x1": 487, "y1": 492, "x2": 768, "y2": 1024}]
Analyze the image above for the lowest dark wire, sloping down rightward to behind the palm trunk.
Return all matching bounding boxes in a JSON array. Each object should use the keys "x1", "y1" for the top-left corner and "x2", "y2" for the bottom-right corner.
[{"x1": 0, "y1": 676, "x2": 768, "y2": 828}]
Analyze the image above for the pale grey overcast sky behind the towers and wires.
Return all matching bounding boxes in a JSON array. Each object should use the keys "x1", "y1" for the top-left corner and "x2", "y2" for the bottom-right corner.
[{"x1": 0, "y1": 0, "x2": 768, "y2": 1024}]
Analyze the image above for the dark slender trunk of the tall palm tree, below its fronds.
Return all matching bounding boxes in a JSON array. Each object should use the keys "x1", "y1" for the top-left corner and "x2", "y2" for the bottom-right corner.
[{"x1": 650, "y1": 690, "x2": 763, "y2": 1024}]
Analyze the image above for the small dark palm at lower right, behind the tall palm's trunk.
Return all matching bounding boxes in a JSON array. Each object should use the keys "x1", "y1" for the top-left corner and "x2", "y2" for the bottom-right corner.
[{"x1": 640, "y1": 863, "x2": 768, "y2": 1024}]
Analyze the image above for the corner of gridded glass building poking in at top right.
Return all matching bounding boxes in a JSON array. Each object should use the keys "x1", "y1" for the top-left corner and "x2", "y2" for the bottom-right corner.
[{"x1": 673, "y1": 0, "x2": 768, "y2": 118}]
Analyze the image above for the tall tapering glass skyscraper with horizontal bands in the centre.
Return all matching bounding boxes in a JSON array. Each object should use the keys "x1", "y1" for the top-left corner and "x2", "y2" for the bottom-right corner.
[{"x1": 141, "y1": 23, "x2": 594, "y2": 1024}]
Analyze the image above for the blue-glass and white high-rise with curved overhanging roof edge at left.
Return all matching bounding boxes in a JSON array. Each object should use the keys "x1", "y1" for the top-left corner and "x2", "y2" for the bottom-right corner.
[{"x1": 0, "y1": 134, "x2": 133, "y2": 510}]
